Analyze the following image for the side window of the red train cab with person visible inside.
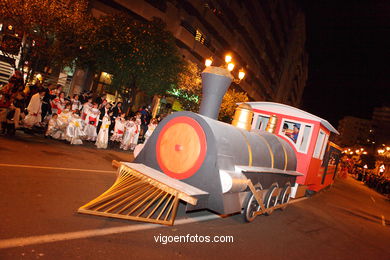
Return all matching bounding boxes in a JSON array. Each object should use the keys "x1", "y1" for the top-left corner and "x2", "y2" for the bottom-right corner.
[{"x1": 279, "y1": 120, "x2": 313, "y2": 153}]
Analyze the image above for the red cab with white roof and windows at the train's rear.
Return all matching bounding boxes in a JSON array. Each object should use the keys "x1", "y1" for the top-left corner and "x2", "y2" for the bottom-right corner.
[{"x1": 248, "y1": 102, "x2": 341, "y2": 198}]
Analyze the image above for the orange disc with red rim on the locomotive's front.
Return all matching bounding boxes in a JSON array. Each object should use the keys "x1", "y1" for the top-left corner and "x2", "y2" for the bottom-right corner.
[{"x1": 156, "y1": 116, "x2": 207, "y2": 180}]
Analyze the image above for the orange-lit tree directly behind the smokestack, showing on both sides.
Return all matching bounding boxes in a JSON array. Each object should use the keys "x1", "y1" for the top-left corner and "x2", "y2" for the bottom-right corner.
[{"x1": 173, "y1": 61, "x2": 249, "y2": 123}]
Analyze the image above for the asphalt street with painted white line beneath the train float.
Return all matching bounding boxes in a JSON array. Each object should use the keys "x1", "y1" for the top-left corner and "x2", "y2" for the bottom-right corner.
[{"x1": 0, "y1": 132, "x2": 390, "y2": 260}]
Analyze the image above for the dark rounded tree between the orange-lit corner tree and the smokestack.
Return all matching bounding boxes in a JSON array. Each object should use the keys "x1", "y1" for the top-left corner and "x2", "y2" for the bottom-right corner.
[{"x1": 85, "y1": 13, "x2": 182, "y2": 102}]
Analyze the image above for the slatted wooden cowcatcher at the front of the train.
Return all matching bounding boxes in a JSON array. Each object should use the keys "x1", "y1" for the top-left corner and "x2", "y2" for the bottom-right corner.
[{"x1": 78, "y1": 161, "x2": 206, "y2": 225}]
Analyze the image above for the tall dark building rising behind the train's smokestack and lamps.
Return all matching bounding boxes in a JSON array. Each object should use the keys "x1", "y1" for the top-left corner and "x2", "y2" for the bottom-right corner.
[{"x1": 85, "y1": 0, "x2": 308, "y2": 106}]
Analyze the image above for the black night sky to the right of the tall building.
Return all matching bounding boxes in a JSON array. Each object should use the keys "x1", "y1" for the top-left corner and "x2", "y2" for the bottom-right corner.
[{"x1": 299, "y1": 0, "x2": 390, "y2": 126}]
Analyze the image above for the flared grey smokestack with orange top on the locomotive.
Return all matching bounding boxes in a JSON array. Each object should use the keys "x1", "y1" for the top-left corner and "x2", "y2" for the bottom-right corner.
[{"x1": 199, "y1": 66, "x2": 233, "y2": 119}]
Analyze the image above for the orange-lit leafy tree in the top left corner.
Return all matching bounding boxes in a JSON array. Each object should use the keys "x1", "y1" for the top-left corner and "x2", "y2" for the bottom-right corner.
[{"x1": 0, "y1": 0, "x2": 94, "y2": 82}]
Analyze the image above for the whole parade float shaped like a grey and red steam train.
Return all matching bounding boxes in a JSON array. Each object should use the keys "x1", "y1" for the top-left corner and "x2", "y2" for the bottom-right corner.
[{"x1": 78, "y1": 66, "x2": 341, "y2": 225}]
